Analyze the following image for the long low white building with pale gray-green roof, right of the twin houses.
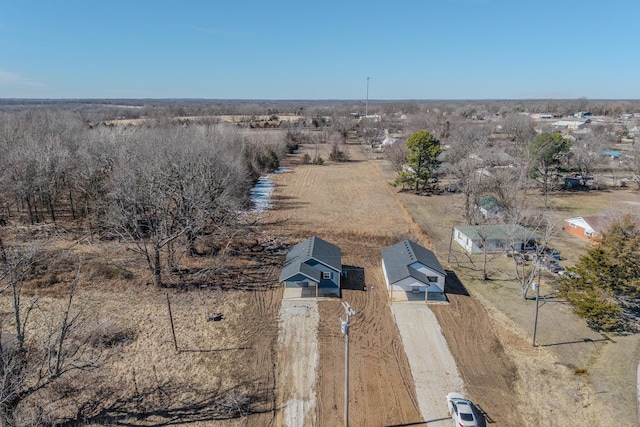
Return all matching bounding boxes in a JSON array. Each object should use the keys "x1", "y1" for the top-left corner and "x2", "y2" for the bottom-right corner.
[{"x1": 453, "y1": 224, "x2": 541, "y2": 254}]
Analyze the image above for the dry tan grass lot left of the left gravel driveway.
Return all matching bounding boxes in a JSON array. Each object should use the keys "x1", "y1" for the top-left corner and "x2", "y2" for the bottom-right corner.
[{"x1": 0, "y1": 234, "x2": 282, "y2": 426}]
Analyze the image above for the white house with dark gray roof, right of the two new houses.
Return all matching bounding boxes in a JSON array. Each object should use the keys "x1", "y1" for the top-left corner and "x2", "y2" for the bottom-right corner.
[{"x1": 382, "y1": 240, "x2": 447, "y2": 301}]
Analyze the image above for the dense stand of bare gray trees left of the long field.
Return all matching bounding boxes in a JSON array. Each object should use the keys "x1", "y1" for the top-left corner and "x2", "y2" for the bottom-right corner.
[{"x1": 0, "y1": 110, "x2": 290, "y2": 285}]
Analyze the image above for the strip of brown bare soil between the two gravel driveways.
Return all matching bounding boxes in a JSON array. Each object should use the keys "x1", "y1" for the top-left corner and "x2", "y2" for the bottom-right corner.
[{"x1": 316, "y1": 268, "x2": 422, "y2": 426}]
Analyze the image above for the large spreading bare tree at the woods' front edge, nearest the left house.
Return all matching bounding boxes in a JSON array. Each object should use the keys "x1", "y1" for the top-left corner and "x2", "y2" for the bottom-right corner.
[{"x1": 104, "y1": 123, "x2": 253, "y2": 286}]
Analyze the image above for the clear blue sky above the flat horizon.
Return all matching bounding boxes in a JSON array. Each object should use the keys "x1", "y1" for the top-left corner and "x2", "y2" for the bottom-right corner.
[{"x1": 0, "y1": 0, "x2": 640, "y2": 100}]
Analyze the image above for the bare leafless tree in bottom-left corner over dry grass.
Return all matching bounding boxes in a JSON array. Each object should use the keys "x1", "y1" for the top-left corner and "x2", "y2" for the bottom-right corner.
[{"x1": 0, "y1": 242, "x2": 101, "y2": 426}]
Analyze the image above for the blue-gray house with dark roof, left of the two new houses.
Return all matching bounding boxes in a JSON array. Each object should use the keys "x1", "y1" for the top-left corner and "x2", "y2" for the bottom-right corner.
[{"x1": 280, "y1": 236, "x2": 342, "y2": 297}]
